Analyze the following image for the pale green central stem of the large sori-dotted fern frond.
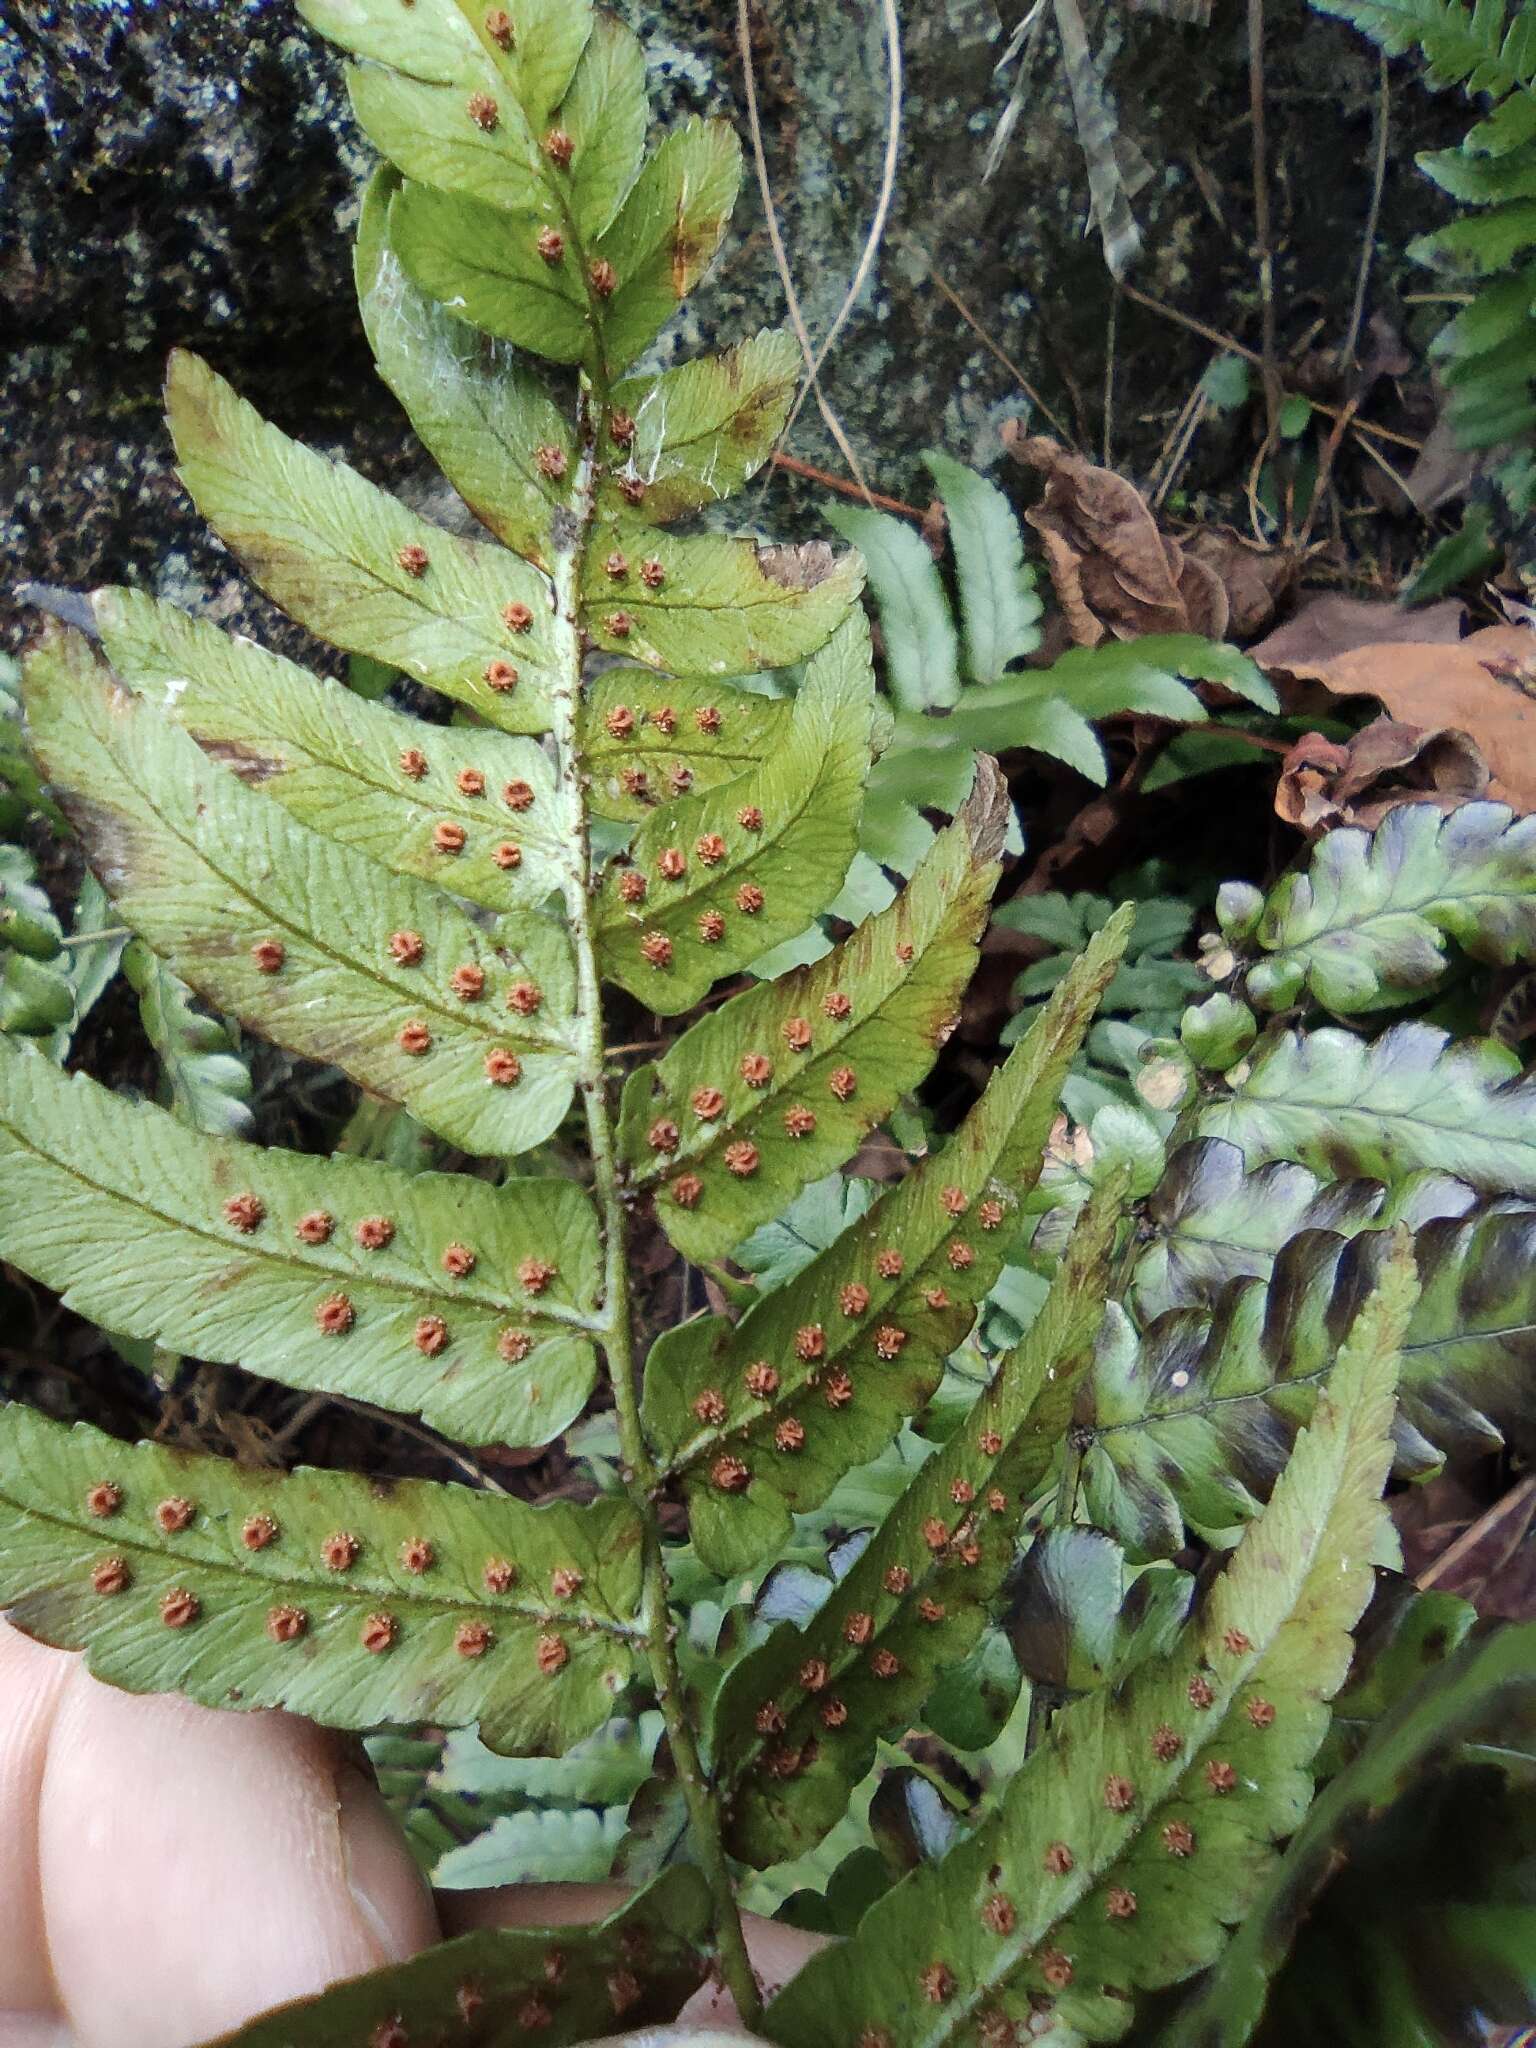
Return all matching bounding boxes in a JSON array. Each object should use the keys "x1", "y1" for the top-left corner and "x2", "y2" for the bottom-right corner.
[{"x1": 553, "y1": 407, "x2": 762, "y2": 2028}]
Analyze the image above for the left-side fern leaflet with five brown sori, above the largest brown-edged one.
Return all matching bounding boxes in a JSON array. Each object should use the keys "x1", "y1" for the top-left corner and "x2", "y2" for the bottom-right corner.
[{"x1": 92, "y1": 590, "x2": 573, "y2": 909}]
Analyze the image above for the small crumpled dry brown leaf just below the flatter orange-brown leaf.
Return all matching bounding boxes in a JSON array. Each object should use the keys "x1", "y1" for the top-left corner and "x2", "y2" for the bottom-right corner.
[{"x1": 1274, "y1": 719, "x2": 1489, "y2": 838}]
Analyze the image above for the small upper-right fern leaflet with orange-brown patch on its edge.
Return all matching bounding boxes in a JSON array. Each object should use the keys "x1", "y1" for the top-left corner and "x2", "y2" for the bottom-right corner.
[{"x1": 594, "y1": 117, "x2": 741, "y2": 373}]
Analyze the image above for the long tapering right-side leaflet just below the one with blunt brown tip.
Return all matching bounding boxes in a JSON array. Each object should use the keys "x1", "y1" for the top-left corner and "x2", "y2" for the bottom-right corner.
[{"x1": 645, "y1": 915, "x2": 1128, "y2": 1573}]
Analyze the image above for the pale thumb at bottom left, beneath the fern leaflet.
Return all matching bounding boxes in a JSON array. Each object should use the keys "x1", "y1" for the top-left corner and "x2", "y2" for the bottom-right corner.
[{"x1": 37, "y1": 1665, "x2": 438, "y2": 2048}]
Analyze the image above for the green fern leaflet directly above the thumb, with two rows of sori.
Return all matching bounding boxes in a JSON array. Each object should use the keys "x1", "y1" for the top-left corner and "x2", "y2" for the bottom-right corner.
[{"x1": 0, "y1": 1405, "x2": 641, "y2": 1749}]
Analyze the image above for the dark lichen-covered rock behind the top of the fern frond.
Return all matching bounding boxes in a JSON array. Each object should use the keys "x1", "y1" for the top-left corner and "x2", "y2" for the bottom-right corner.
[{"x1": 0, "y1": 0, "x2": 1374, "y2": 651}]
